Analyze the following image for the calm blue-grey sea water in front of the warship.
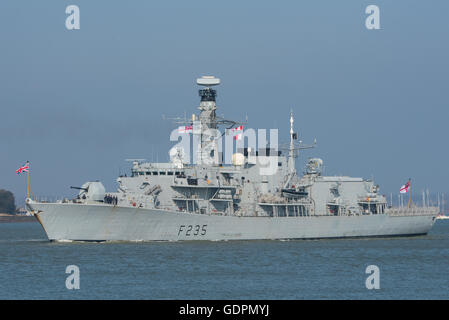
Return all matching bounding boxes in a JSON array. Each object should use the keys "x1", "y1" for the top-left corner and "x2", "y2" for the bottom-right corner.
[{"x1": 0, "y1": 220, "x2": 449, "y2": 299}]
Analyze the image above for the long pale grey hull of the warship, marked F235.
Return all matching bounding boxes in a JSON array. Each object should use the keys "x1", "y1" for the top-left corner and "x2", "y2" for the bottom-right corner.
[{"x1": 27, "y1": 203, "x2": 435, "y2": 241}]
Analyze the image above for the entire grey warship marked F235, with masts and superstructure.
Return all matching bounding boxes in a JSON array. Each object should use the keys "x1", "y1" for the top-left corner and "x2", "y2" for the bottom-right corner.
[{"x1": 26, "y1": 76, "x2": 438, "y2": 241}]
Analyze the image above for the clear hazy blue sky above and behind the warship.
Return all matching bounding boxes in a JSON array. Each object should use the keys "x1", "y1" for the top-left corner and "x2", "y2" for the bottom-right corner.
[{"x1": 0, "y1": 0, "x2": 449, "y2": 202}]
